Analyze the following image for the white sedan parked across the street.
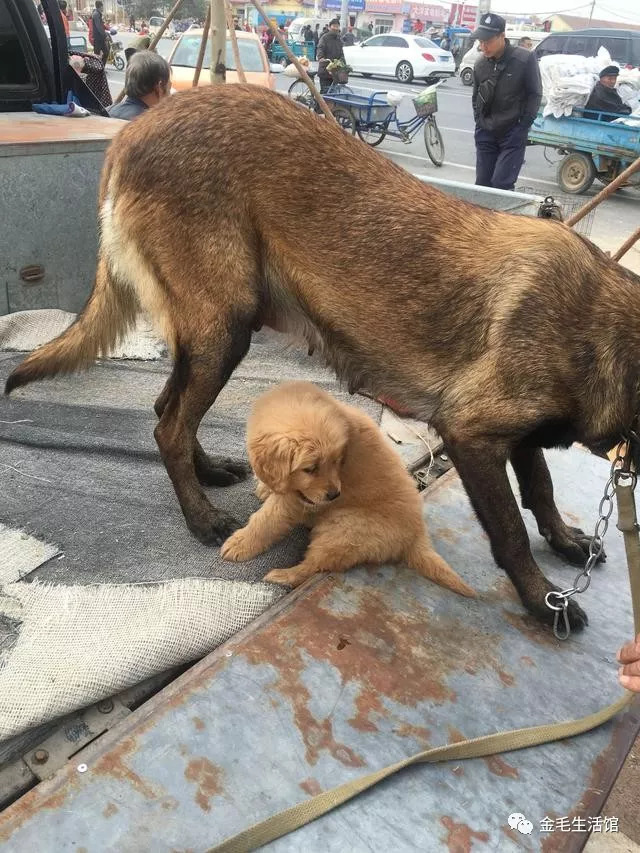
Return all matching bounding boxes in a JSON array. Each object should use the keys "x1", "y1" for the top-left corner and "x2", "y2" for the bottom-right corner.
[{"x1": 344, "y1": 33, "x2": 456, "y2": 83}]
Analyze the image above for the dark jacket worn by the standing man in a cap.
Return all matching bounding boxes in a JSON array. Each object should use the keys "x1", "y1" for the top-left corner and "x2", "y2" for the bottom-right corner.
[{"x1": 472, "y1": 44, "x2": 542, "y2": 137}]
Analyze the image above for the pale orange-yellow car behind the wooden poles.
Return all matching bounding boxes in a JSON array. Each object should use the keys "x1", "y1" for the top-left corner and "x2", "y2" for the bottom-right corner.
[{"x1": 168, "y1": 29, "x2": 276, "y2": 92}]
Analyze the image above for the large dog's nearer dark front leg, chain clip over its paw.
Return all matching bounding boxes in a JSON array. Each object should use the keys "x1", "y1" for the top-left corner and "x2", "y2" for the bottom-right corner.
[{"x1": 445, "y1": 438, "x2": 588, "y2": 630}]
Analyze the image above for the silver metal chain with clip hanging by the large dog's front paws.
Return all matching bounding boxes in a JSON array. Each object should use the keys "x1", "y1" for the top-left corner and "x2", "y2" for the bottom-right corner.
[{"x1": 544, "y1": 442, "x2": 636, "y2": 640}]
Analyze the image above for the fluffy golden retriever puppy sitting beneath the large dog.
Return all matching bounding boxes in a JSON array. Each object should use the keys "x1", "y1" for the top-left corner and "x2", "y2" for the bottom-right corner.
[{"x1": 222, "y1": 382, "x2": 475, "y2": 596}]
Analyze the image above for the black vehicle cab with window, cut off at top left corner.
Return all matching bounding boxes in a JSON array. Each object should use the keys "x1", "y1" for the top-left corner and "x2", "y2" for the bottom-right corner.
[{"x1": 0, "y1": 0, "x2": 107, "y2": 115}]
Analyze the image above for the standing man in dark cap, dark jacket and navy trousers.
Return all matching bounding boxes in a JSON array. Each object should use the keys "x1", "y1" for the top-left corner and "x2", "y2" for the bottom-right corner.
[{"x1": 471, "y1": 12, "x2": 542, "y2": 190}]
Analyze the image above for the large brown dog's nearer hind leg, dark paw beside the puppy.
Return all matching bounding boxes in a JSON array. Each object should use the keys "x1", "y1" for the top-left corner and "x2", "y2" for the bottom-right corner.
[{"x1": 154, "y1": 305, "x2": 254, "y2": 545}]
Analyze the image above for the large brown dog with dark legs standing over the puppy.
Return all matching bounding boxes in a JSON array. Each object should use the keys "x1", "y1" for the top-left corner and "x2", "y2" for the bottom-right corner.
[{"x1": 6, "y1": 85, "x2": 640, "y2": 628}]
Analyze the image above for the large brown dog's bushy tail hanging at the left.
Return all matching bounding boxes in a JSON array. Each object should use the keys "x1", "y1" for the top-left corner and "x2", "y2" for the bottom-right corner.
[{"x1": 4, "y1": 258, "x2": 139, "y2": 394}]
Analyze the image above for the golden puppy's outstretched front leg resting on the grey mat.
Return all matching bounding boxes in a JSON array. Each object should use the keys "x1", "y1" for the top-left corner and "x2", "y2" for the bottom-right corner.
[{"x1": 220, "y1": 494, "x2": 301, "y2": 563}]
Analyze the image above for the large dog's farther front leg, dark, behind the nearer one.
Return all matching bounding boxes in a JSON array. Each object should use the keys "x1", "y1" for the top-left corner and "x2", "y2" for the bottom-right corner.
[{"x1": 511, "y1": 446, "x2": 606, "y2": 566}]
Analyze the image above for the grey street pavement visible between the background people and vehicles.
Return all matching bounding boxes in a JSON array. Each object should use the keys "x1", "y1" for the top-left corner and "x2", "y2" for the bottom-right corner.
[{"x1": 107, "y1": 32, "x2": 640, "y2": 262}]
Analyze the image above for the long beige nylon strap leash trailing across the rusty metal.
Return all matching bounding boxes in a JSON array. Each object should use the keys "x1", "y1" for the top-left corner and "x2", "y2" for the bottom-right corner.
[{"x1": 207, "y1": 485, "x2": 640, "y2": 853}]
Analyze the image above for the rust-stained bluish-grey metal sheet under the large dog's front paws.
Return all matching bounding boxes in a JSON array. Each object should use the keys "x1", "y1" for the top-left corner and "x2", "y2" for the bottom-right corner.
[{"x1": 0, "y1": 450, "x2": 640, "y2": 853}]
